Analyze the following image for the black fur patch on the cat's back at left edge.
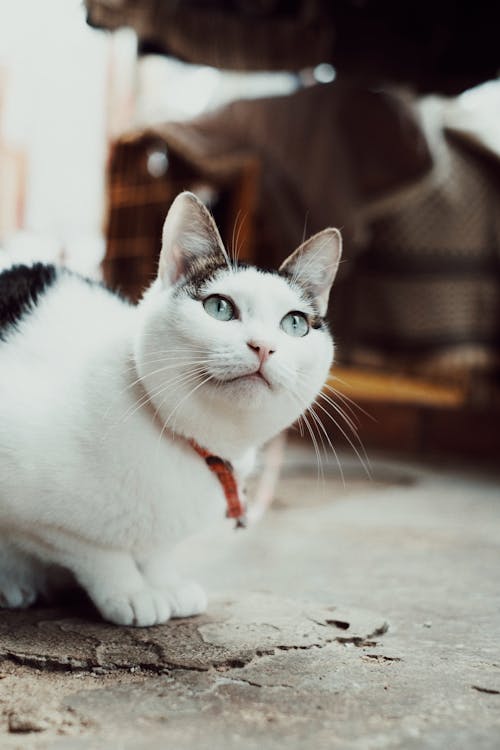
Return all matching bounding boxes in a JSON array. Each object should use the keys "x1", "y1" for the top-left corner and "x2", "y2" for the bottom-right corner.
[{"x1": 0, "y1": 263, "x2": 57, "y2": 341}]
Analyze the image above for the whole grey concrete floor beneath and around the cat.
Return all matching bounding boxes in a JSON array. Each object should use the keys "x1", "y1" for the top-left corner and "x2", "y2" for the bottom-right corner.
[{"x1": 0, "y1": 446, "x2": 500, "y2": 750}]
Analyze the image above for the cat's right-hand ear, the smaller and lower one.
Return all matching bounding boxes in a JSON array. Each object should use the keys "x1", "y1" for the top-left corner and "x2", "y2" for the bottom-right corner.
[{"x1": 279, "y1": 228, "x2": 342, "y2": 315}]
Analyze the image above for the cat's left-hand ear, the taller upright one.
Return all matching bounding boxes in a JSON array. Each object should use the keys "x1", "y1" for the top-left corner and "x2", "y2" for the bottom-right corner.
[{"x1": 158, "y1": 191, "x2": 227, "y2": 286}]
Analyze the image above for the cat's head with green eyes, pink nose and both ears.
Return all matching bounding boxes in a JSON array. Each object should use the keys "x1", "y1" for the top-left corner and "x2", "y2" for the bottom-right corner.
[{"x1": 135, "y1": 193, "x2": 341, "y2": 456}]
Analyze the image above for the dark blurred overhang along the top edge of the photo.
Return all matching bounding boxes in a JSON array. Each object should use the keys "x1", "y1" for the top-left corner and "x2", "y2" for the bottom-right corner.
[{"x1": 86, "y1": 0, "x2": 500, "y2": 94}]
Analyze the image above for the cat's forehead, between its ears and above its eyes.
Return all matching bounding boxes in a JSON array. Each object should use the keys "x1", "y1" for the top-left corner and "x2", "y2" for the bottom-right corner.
[{"x1": 203, "y1": 268, "x2": 313, "y2": 312}]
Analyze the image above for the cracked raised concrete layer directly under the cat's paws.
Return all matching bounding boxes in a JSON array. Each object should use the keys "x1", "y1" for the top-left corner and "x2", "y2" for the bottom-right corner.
[{"x1": 0, "y1": 592, "x2": 388, "y2": 674}]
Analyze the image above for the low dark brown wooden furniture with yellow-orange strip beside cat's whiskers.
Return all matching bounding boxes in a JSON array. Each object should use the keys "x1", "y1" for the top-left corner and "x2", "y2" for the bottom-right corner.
[{"x1": 323, "y1": 367, "x2": 500, "y2": 464}]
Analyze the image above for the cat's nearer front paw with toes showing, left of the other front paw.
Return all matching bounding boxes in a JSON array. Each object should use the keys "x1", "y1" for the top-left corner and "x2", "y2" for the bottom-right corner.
[{"x1": 97, "y1": 587, "x2": 172, "y2": 628}]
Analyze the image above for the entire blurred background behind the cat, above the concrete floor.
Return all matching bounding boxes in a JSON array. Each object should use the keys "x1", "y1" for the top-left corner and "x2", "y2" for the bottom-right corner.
[{"x1": 0, "y1": 0, "x2": 500, "y2": 459}]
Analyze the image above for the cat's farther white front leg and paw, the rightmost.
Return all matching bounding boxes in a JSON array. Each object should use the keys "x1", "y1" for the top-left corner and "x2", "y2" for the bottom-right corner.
[{"x1": 137, "y1": 550, "x2": 207, "y2": 617}]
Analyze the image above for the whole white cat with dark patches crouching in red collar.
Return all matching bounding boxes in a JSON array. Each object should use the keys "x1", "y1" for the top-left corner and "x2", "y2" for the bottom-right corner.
[{"x1": 0, "y1": 192, "x2": 341, "y2": 626}]
